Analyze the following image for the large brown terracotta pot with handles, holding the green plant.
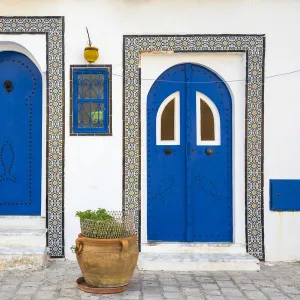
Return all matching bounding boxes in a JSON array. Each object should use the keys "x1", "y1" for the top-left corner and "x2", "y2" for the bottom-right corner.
[{"x1": 75, "y1": 234, "x2": 139, "y2": 288}]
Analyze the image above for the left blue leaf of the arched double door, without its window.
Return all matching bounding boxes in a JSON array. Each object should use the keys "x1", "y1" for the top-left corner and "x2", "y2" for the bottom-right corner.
[{"x1": 147, "y1": 65, "x2": 186, "y2": 241}]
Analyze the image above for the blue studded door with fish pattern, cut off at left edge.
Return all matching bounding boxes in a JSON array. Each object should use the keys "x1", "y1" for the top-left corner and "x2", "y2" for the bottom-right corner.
[{"x1": 0, "y1": 51, "x2": 42, "y2": 215}]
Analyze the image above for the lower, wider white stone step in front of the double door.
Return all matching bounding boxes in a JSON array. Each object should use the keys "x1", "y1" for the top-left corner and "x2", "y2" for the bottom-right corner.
[{"x1": 138, "y1": 253, "x2": 260, "y2": 271}]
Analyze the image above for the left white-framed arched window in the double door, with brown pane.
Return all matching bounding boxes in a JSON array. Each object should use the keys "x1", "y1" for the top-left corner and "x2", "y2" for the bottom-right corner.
[{"x1": 156, "y1": 92, "x2": 180, "y2": 145}]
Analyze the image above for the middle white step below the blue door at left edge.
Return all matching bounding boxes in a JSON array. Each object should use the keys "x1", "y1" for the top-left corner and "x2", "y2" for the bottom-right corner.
[{"x1": 0, "y1": 228, "x2": 47, "y2": 248}]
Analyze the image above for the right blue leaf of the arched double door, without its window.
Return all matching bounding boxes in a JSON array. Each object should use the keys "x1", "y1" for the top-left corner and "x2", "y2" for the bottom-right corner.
[{"x1": 187, "y1": 65, "x2": 233, "y2": 242}]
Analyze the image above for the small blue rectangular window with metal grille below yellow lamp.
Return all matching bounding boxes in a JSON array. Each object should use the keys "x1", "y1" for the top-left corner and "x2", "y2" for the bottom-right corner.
[{"x1": 72, "y1": 68, "x2": 111, "y2": 134}]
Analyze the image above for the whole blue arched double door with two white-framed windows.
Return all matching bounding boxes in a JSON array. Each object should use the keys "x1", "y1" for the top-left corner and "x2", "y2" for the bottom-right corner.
[{"x1": 147, "y1": 64, "x2": 232, "y2": 242}]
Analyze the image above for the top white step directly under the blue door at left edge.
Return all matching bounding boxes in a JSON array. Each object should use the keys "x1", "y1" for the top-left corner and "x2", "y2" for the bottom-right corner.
[{"x1": 0, "y1": 216, "x2": 46, "y2": 230}]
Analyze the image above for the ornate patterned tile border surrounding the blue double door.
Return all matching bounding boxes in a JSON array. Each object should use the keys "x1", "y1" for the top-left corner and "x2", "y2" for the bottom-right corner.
[{"x1": 123, "y1": 35, "x2": 265, "y2": 260}]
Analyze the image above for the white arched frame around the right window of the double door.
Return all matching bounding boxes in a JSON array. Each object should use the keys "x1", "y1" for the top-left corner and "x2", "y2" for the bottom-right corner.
[{"x1": 196, "y1": 92, "x2": 221, "y2": 146}]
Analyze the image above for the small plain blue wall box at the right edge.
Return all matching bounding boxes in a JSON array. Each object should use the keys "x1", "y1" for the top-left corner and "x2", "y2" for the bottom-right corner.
[{"x1": 270, "y1": 179, "x2": 300, "y2": 211}]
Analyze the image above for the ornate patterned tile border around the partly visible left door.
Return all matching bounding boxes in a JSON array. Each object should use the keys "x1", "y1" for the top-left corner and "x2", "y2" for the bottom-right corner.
[{"x1": 0, "y1": 17, "x2": 65, "y2": 257}]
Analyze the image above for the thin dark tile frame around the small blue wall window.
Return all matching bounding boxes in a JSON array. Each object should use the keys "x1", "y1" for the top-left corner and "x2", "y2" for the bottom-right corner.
[{"x1": 70, "y1": 64, "x2": 112, "y2": 136}]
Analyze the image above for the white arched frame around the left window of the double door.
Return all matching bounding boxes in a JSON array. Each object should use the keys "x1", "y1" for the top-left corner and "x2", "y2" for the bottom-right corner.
[{"x1": 156, "y1": 91, "x2": 180, "y2": 145}]
